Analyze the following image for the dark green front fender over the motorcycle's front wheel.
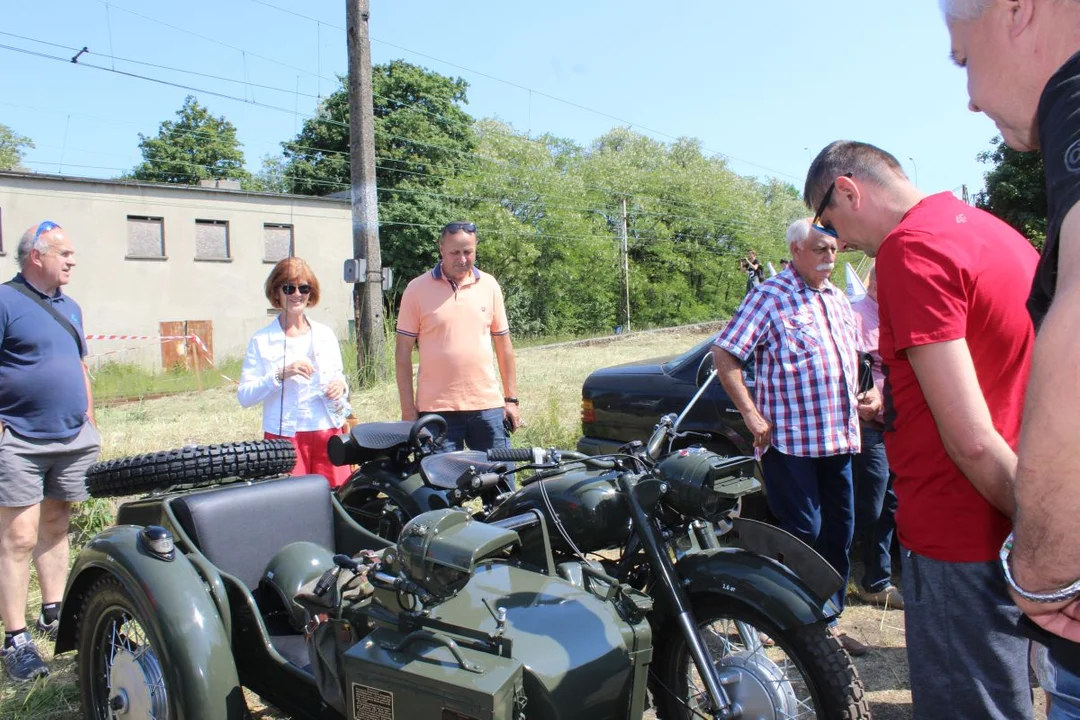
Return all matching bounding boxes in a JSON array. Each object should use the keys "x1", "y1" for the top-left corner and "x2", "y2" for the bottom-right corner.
[{"x1": 675, "y1": 547, "x2": 840, "y2": 630}]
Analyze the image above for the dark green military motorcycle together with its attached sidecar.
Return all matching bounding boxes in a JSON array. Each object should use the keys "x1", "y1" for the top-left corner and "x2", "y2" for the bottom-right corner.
[{"x1": 50, "y1": 427, "x2": 866, "y2": 720}]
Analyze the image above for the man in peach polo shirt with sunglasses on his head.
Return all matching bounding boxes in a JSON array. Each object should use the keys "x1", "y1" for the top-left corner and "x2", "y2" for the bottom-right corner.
[{"x1": 394, "y1": 222, "x2": 522, "y2": 450}]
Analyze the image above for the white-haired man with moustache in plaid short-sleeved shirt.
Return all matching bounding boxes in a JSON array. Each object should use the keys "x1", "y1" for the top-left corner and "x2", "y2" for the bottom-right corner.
[{"x1": 713, "y1": 219, "x2": 880, "y2": 654}]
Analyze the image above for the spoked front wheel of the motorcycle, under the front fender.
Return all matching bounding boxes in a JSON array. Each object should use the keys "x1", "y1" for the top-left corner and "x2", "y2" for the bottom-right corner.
[{"x1": 650, "y1": 598, "x2": 870, "y2": 720}]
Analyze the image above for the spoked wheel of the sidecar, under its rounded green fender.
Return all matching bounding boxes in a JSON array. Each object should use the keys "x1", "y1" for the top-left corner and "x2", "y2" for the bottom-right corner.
[{"x1": 78, "y1": 576, "x2": 172, "y2": 720}]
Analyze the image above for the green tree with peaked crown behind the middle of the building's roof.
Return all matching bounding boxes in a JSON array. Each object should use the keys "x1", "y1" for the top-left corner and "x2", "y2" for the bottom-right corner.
[{"x1": 131, "y1": 95, "x2": 252, "y2": 187}]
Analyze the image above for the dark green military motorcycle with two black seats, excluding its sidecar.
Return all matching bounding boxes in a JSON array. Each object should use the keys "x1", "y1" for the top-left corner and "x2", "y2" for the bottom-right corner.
[{"x1": 332, "y1": 363, "x2": 869, "y2": 720}]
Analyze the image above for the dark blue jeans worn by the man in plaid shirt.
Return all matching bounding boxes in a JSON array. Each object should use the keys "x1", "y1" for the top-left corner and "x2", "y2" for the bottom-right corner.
[{"x1": 761, "y1": 448, "x2": 855, "y2": 610}]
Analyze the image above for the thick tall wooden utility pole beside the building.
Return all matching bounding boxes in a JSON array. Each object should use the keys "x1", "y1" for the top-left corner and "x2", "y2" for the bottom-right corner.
[{"x1": 346, "y1": 0, "x2": 386, "y2": 382}]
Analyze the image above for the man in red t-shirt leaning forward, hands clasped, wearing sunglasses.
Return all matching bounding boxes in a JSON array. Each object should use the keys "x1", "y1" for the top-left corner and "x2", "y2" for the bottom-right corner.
[{"x1": 805, "y1": 140, "x2": 1038, "y2": 720}]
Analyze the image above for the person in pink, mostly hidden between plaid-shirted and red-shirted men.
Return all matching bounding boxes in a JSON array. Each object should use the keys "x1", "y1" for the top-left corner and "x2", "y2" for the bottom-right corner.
[{"x1": 851, "y1": 268, "x2": 904, "y2": 610}]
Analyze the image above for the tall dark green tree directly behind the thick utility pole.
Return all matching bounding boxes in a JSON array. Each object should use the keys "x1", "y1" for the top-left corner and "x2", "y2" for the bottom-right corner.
[{"x1": 282, "y1": 60, "x2": 473, "y2": 283}]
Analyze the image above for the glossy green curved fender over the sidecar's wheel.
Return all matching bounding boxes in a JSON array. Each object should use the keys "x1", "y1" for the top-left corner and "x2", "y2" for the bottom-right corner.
[{"x1": 56, "y1": 525, "x2": 243, "y2": 718}]
